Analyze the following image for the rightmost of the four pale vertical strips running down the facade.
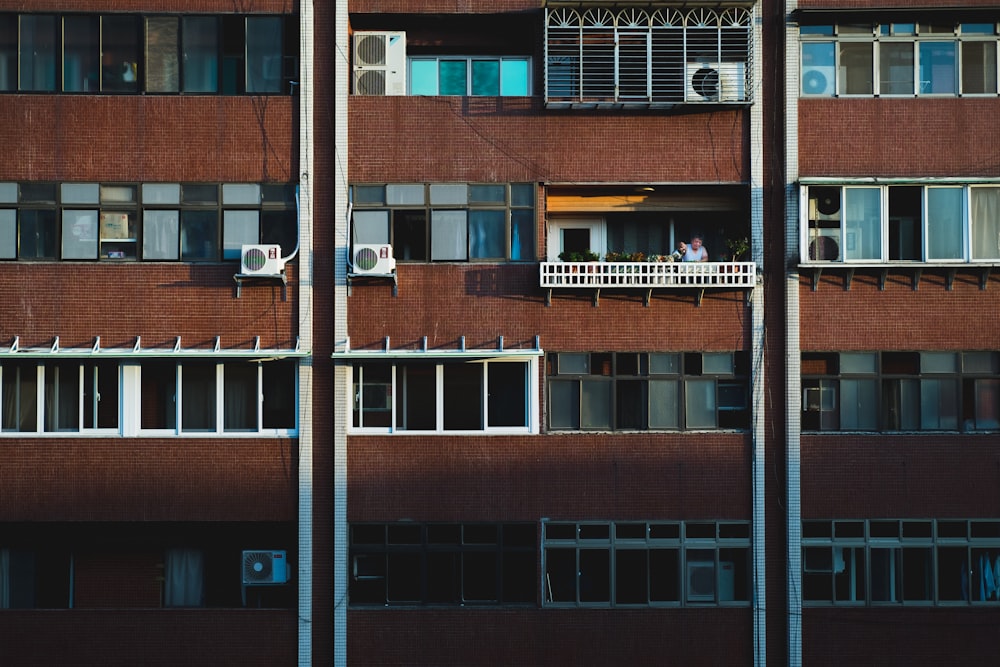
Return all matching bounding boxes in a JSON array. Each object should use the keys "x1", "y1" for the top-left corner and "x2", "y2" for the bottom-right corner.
[{"x1": 785, "y1": 0, "x2": 802, "y2": 667}]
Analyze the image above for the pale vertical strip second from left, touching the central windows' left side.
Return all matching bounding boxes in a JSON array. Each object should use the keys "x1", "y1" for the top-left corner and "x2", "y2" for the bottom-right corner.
[{"x1": 329, "y1": 0, "x2": 352, "y2": 667}]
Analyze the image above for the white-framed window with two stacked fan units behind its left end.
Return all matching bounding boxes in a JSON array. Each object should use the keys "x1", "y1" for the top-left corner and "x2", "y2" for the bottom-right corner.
[{"x1": 802, "y1": 183, "x2": 1000, "y2": 263}]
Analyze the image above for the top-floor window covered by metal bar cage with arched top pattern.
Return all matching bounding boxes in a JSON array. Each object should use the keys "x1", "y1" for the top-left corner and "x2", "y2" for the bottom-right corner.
[{"x1": 545, "y1": 6, "x2": 753, "y2": 106}]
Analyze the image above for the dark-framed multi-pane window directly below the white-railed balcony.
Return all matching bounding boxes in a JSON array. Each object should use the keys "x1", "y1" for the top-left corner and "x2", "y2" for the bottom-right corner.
[{"x1": 546, "y1": 352, "x2": 749, "y2": 431}]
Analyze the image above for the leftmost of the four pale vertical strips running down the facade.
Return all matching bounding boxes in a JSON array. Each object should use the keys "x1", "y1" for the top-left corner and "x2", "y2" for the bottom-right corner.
[{"x1": 291, "y1": 0, "x2": 314, "y2": 667}]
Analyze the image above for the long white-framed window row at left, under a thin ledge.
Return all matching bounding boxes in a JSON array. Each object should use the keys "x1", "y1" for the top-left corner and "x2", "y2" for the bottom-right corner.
[{"x1": 0, "y1": 358, "x2": 297, "y2": 436}]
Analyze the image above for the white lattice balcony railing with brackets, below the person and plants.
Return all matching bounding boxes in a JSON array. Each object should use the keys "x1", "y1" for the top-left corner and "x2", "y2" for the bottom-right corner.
[{"x1": 539, "y1": 262, "x2": 757, "y2": 306}]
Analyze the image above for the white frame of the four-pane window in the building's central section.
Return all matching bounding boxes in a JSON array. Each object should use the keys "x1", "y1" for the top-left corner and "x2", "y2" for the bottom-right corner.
[{"x1": 347, "y1": 353, "x2": 540, "y2": 436}]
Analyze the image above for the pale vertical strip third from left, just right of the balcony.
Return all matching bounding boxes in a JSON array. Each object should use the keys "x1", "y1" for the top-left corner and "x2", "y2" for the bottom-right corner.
[{"x1": 750, "y1": 3, "x2": 767, "y2": 667}]
